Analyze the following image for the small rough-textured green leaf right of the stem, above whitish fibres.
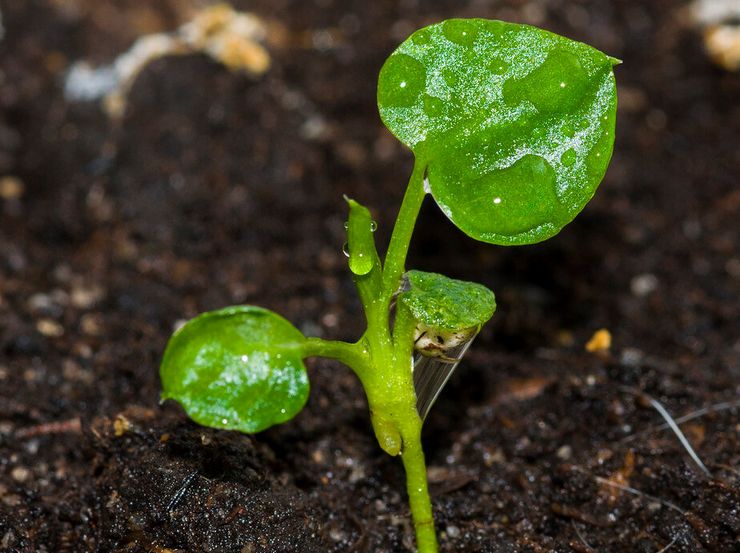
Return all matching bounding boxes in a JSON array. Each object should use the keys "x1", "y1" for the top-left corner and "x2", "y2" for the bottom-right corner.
[{"x1": 397, "y1": 271, "x2": 496, "y2": 332}]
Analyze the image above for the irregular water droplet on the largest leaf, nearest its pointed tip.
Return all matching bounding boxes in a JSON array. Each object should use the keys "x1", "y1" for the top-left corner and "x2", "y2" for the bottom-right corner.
[{"x1": 503, "y1": 50, "x2": 588, "y2": 114}]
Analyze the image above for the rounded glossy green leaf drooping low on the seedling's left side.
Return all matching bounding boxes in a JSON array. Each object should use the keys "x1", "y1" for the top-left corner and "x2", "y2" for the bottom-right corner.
[{"x1": 160, "y1": 306, "x2": 309, "y2": 432}]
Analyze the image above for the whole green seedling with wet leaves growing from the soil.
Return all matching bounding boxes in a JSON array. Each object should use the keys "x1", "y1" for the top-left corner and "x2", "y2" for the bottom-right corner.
[{"x1": 161, "y1": 19, "x2": 618, "y2": 553}]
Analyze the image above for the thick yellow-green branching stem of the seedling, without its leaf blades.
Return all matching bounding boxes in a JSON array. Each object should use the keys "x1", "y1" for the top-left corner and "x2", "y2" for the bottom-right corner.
[{"x1": 342, "y1": 154, "x2": 437, "y2": 553}]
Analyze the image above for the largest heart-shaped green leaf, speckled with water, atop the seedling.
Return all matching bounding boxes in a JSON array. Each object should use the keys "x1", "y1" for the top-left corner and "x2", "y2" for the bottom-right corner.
[{"x1": 378, "y1": 19, "x2": 618, "y2": 245}]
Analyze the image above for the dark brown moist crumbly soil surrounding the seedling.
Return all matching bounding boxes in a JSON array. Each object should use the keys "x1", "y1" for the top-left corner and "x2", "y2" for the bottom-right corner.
[{"x1": 0, "y1": 0, "x2": 740, "y2": 553}]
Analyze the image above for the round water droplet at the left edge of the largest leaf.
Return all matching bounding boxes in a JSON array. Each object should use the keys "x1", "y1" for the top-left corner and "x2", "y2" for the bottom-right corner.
[{"x1": 378, "y1": 54, "x2": 427, "y2": 107}]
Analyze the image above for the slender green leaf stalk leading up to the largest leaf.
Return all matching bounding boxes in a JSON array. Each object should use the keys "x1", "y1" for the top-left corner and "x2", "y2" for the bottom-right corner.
[{"x1": 383, "y1": 159, "x2": 426, "y2": 303}]
